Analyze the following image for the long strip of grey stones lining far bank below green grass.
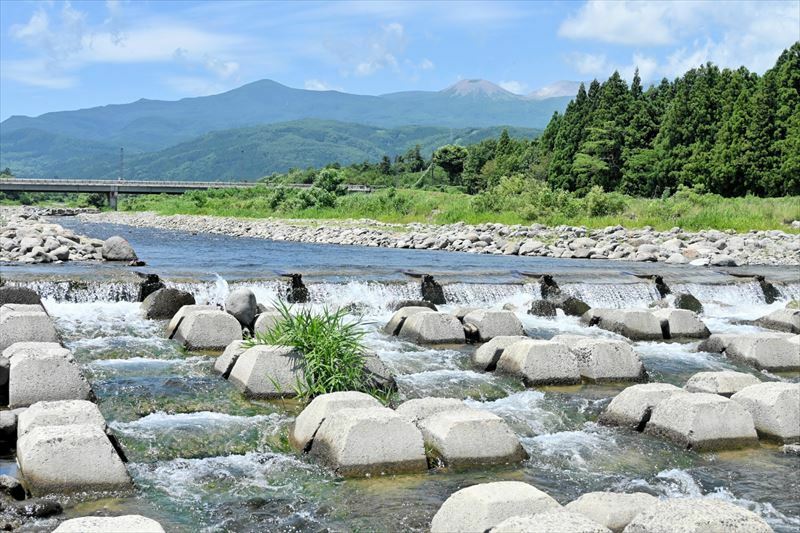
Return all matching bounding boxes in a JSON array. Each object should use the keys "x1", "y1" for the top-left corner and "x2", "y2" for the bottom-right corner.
[{"x1": 79, "y1": 212, "x2": 800, "y2": 266}]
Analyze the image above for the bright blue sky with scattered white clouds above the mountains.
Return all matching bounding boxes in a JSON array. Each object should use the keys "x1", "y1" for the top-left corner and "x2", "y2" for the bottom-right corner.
[{"x1": 0, "y1": 0, "x2": 800, "y2": 119}]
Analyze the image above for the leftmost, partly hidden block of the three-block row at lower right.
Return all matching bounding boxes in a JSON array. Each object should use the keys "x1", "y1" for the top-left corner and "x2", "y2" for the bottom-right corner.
[{"x1": 599, "y1": 383, "x2": 688, "y2": 431}]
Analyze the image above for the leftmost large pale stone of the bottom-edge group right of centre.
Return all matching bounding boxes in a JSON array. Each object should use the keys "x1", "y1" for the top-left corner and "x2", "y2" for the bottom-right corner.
[{"x1": 431, "y1": 481, "x2": 561, "y2": 533}]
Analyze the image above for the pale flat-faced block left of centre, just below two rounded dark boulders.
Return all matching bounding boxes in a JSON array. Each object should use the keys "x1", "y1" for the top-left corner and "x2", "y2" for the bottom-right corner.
[{"x1": 172, "y1": 310, "x2": 242, "y2": 350}]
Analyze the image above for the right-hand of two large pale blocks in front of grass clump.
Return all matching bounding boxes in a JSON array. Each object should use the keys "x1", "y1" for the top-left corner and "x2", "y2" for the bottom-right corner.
[{"x1": 417, "y1": 408, "x2": 528, "y2": 468}]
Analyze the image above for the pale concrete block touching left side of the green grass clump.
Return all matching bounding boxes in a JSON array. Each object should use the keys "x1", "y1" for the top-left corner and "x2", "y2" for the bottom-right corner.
[{"x1": 228, "y1": 344, "x2": 304, "y2": 398}]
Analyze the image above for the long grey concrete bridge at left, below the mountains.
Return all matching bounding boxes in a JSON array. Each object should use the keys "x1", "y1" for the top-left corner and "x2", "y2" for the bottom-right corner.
[{"x1": 0, "y1": 178, "x2": 373, "y2": 209}]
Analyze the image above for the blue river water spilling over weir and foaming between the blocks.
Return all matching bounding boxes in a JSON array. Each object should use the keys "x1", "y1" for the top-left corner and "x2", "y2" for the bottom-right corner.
[{"x1": 0, "y1": 221, "x2": 800, "y2": 532}]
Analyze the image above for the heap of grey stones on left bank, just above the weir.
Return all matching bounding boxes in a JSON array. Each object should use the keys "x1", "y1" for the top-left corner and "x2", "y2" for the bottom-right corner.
[{"x1": 0, "y1": 207, "x2": 136, "y2": 264}]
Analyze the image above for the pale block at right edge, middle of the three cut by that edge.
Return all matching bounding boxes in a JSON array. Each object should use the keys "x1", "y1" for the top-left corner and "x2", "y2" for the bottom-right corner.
[{"x1": 725, "y1": 333, "x2": 800, "y2": 371}]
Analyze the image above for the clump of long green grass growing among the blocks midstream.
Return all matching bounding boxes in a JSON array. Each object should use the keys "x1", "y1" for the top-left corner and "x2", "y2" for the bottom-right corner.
[{"x1": 245, "y1": 301, "x2": 388, "y2": 402}]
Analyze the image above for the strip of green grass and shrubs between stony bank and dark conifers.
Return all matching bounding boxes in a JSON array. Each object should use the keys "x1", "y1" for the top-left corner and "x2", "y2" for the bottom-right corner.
[{"x1": 121, "y1": 185, "x2": 800, "y2": 232}]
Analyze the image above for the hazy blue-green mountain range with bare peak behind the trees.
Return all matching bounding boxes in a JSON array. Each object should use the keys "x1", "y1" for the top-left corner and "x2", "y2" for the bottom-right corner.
[{"x1": 0, "y1": 80, "x2": 571, "y2": 180}]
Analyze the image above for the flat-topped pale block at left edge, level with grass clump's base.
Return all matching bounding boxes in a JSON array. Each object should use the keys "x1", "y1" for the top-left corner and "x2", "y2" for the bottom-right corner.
[{"x1": 3, "y1": 342, "x2": 92, "y2": 407}]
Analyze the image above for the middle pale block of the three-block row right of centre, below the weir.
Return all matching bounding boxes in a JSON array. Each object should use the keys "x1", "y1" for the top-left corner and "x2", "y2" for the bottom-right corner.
[{"x1": 497, "y1": 339, "x2": 581, "y2": 385}]
